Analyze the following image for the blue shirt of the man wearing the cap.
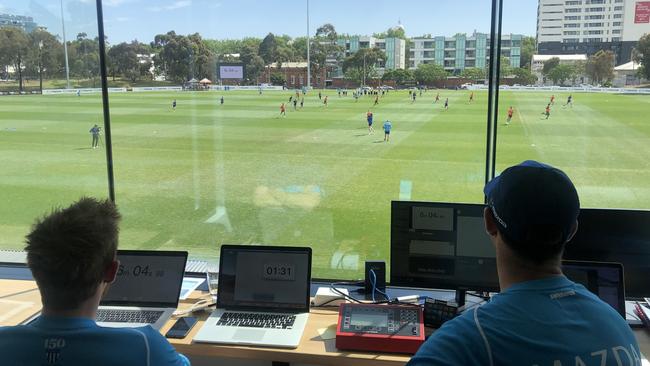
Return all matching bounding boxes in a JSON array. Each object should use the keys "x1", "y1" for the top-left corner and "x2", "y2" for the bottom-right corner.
[{"x1": 408, "y1": 276, "x2": 641, "y2": 366}]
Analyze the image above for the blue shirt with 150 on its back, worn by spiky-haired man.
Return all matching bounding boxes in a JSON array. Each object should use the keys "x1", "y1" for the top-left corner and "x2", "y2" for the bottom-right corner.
[{"x1": 0, "y1": 316, "x2": 190, "y2": 366}]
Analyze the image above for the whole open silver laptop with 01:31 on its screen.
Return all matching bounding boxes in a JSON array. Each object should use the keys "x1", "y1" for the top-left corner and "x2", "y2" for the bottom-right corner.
[{"x1": 193, "y1": 245, "x2": 311, "y2": 348}]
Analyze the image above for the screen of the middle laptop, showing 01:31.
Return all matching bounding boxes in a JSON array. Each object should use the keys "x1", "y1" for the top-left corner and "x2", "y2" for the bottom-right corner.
[{"x1": 217, "y1": 245, "x2": 311, "y2": 312}]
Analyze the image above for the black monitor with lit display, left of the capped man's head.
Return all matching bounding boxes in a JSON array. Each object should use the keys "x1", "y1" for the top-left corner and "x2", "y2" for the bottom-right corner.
[{"x1": 390, "y1": 201, "x2": 499, "y2": 302}]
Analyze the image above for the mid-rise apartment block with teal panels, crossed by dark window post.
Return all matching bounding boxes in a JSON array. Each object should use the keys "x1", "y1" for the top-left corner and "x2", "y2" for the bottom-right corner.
[{"x1": 408, "y1": 33, "x2": 523, "y2": 74}]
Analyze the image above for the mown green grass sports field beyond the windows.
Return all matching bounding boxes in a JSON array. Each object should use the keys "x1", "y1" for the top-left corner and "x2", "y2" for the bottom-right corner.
[{"x1": 0, "y1": 91, "x2": 650, "y2": 278}]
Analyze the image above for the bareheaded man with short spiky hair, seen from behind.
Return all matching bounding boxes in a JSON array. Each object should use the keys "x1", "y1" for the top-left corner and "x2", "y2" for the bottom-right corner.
[{"x1": 0, "y1": 198, "x2": 190, "y2": 366}]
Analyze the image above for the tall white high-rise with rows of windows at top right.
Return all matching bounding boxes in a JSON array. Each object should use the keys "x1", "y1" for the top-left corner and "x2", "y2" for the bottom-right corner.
[{"x1": 537, "y1": 0, "x2": 650, "y2": 64}]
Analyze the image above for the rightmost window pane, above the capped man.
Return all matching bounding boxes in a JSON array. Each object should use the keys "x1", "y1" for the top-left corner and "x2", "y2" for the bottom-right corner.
[{"x1": 497, "y1": 0, "x2": 650, "y2": 209}]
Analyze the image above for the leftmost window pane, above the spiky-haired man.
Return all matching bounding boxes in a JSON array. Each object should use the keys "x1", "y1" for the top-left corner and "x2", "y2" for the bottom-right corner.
[{"x1": 0, "y1": 0, "x2": 108, "y2": 249}]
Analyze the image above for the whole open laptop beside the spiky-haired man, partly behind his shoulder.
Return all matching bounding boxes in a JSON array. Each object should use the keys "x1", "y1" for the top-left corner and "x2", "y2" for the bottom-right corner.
[{"x1": 96, "y1": 250, "x2": 187, "y2": 330}]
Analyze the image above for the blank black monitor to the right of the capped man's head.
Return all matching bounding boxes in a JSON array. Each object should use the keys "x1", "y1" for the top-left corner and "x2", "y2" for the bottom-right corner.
[{"x1": 564, "y1": 208, "x2": 650, "y2": 298}]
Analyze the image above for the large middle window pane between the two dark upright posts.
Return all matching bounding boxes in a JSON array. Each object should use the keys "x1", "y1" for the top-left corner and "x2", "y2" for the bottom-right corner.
[{"x1": 105, "y1": 0, "x2": 490, "y2": 278}]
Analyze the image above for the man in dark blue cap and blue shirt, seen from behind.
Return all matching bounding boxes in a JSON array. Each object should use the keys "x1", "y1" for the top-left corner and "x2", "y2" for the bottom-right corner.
[{"x1": 408, "y1": 160, "x2": 641, "y2": 366}]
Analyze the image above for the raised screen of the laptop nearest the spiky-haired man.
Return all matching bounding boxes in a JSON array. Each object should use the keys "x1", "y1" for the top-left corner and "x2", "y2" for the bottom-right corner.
[{"x1": 100, "y1": 250, "x2": 187, "y2": 308}]
